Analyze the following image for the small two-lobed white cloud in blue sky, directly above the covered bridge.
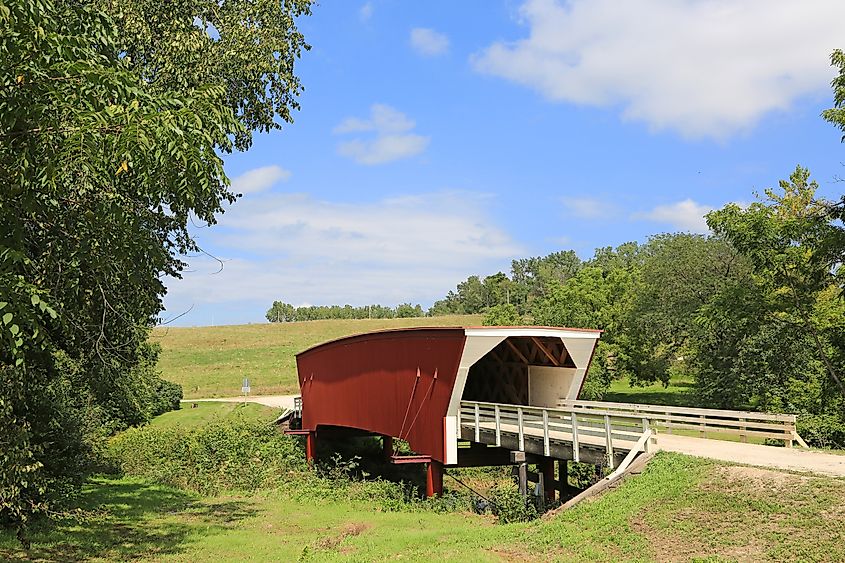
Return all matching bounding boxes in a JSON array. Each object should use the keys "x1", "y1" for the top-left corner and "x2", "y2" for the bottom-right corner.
[{"x1": 334, "y1": 104, "x2": 431, "y2": 165}]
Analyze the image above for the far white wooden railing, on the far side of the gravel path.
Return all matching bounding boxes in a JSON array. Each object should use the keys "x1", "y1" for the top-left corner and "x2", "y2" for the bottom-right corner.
[{"x1": 558, "y1": 400, "x2": 807, "y2": 448}]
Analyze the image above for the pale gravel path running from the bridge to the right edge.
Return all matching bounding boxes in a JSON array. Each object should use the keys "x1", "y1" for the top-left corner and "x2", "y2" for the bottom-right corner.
[{"x1": 657, "y1": 433, "x2": 845, "y2": 477}]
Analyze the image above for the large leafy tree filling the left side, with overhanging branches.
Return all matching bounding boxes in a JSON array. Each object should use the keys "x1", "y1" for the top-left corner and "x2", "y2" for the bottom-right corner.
[{"x1": 0, "y1": 0, "x2": 309, "y2": 524}]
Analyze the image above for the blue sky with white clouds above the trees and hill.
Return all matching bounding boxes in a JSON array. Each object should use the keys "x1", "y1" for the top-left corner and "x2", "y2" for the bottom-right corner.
[{"x1": 162, "y1": 0, "x2": 845, "y2": 326}]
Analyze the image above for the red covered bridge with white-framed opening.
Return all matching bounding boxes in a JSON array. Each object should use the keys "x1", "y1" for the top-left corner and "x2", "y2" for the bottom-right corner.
[{"x1": 296, "y1": 327, "x2": 601, "y2": 494}]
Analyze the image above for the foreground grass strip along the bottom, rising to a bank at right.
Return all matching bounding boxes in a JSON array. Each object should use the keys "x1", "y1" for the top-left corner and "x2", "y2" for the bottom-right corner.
[{"x1": 0, "y1": 453, "x2": 845, "y2": 562}]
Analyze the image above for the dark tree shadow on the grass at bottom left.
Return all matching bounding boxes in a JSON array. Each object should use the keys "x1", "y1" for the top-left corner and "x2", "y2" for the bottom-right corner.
[{"x1": 0, "y1": 477, "x2": 257, "y2": 561}]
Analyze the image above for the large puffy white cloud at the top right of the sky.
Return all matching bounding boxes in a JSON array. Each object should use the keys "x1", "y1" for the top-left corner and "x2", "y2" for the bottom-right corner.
[{"x1": 472, "y1": 0, "x2": 845, "y2": 138}]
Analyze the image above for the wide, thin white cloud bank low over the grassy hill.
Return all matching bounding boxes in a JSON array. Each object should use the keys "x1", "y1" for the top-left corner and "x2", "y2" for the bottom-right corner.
[{"x1": 166, "y1": 192, "x2": 524, "y2": 322}]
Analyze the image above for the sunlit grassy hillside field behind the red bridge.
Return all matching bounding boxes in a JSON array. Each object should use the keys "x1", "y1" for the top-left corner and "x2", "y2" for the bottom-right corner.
[{"x1": 151, "y1": 315, "x2": 481, "y2": 398}]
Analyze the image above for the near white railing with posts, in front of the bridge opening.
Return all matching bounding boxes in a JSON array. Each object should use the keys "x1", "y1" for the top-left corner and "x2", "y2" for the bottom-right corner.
[{"x1": 458, "y1": 401, "x2": 652, "y2": 469}]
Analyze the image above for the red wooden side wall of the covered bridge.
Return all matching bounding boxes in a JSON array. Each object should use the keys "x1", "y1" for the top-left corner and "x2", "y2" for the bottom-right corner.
[{"x1": 296, "y1": 328, "x2": 466, "y2": 462}]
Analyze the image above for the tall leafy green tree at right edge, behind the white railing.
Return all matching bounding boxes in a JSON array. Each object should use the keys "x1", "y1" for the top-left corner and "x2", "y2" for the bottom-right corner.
[{"x1": 697, "y1": 166, "x2": 845, "y2": 445}]
